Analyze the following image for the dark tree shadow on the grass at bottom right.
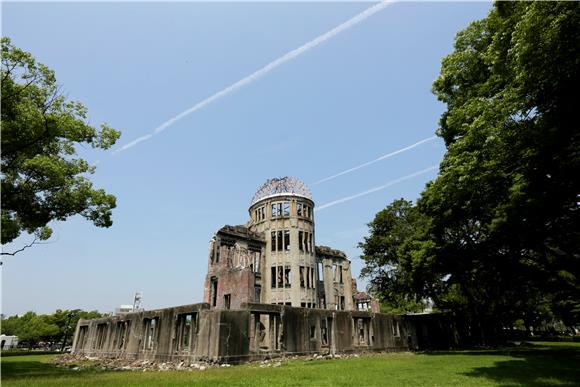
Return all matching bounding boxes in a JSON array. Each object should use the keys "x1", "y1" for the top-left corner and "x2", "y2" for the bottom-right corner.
[{"x1": 427, "y1": 344, "x2": 580, "y2": 387}]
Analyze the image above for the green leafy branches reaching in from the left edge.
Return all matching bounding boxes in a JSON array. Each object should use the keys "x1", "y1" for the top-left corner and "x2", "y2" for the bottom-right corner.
[{"x1": 0, "y1": 37, "x2": 120, "y2": 254}]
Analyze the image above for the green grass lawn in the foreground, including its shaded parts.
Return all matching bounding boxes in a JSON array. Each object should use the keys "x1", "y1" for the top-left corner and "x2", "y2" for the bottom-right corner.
[{"x1": 2, "y1": 343, "x2": 580, "y2": 387}]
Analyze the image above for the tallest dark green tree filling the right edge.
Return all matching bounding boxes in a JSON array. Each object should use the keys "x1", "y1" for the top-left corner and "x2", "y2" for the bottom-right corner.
[{"x1": 360, "y1": 2, "x2": 580, "y2": 341}]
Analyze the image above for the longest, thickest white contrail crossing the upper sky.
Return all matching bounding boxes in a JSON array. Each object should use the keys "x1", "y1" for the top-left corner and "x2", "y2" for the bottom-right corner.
[{"x1": 112, "y1": 1, "x2": 394, "y2": 154}]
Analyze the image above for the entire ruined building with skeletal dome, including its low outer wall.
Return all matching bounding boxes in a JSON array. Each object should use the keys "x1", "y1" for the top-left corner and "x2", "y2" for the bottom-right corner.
[{"x1": 72, "y1": 177, "x2": 455, "y2": 362}]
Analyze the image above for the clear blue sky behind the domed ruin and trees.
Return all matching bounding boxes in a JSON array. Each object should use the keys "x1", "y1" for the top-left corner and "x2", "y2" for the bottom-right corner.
[{"x1": 2, "y1": 2, "x2": 491, "y2": 315}]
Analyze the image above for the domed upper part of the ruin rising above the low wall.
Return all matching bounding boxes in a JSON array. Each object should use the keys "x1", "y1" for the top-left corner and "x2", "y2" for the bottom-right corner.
[{"x1": 204, "y1": 177, "x2": 356, "y2": 310}]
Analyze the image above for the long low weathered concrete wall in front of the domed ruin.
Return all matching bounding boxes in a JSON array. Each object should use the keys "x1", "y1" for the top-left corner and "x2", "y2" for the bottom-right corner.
[{"x1": 73, "y1": 303, "x2": 440, "y2": 363}]
